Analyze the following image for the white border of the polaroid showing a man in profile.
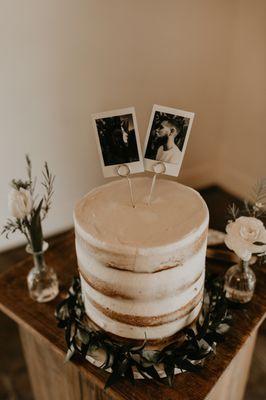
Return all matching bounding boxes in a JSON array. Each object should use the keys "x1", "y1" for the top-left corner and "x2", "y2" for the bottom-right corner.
[{"x1": 143, "y1": 104, "x2": 195, "y2": 177}]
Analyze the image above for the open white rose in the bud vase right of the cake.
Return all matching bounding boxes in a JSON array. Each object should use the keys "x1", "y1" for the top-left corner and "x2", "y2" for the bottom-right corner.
[{"x1": 224, "y1": 217, "x2": 266, "y2": 261}]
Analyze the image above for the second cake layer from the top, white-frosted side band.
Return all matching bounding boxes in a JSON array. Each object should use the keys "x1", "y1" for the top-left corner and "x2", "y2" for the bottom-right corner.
[{"x1": 76, "y1": 239, "x2": 206, "y2": 301}]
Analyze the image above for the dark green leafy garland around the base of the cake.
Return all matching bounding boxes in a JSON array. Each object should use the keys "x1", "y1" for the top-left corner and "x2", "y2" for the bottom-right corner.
[{"x1": 56, "y1": 277, "x2": 232, "y2": 387}]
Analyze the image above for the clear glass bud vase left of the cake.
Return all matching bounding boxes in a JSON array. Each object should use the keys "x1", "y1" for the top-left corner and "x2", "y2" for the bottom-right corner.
[{"x1": 26, "y1": 242, "x2": 59, "y2": 303}]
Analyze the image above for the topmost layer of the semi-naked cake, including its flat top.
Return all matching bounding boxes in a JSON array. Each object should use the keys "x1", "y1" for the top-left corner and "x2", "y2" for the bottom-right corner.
[{"x1": 74, "y1": 177, "x2": 208, "y2": 272}]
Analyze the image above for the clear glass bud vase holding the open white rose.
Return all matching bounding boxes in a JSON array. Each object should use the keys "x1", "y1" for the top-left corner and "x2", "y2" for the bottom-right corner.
[{"x1": 224, "y1": 260, "x2": 256, "y2": 304}]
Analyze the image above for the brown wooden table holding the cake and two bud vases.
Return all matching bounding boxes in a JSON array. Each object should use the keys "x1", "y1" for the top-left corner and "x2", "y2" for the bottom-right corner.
[{"x1": 0, "y1": 188, "x2": 266, "y2": 400}]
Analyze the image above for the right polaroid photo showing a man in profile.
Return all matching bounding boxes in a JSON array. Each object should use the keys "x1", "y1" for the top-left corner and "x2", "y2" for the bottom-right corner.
[{"x1": 144, "y1": 104, "x2": 194, "y2": 176}]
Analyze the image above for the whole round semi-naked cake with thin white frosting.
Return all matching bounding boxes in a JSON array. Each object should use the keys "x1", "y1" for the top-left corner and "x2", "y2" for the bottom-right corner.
[{"x1": 74, "y1": 177, "x2": 209, "y2": 340}]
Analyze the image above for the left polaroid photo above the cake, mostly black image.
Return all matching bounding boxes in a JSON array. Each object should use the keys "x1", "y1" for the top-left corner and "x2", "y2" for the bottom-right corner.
[{"x1": 92, "y1": 107, "x2": 144, "y2": 178}]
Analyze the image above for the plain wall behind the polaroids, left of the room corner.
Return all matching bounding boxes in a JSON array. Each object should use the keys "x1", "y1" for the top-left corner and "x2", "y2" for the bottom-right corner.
[{"x1": 0, "y1": 0, "x2": 263, "y2": 249}]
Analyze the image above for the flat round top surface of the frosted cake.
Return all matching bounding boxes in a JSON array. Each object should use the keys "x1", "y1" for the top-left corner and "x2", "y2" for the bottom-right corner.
[{"x1": 74, "y1": 177, "x2": 208, "y2": 248}]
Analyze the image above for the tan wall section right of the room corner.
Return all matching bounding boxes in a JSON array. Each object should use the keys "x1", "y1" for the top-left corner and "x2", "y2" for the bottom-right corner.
[{"x1": 217, "y1": 0, "x2": 266, "y2": 197}]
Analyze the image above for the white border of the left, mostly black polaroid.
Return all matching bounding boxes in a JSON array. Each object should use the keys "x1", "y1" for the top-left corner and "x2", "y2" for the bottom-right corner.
[{"x1": 91, "y1": 107, "x2": 144, "y2": 178}]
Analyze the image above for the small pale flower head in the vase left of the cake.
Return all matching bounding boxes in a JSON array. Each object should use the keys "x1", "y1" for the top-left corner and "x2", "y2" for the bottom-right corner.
[{"x1": 8, "y1": 188, "x2": 32, "y2": 219}]
